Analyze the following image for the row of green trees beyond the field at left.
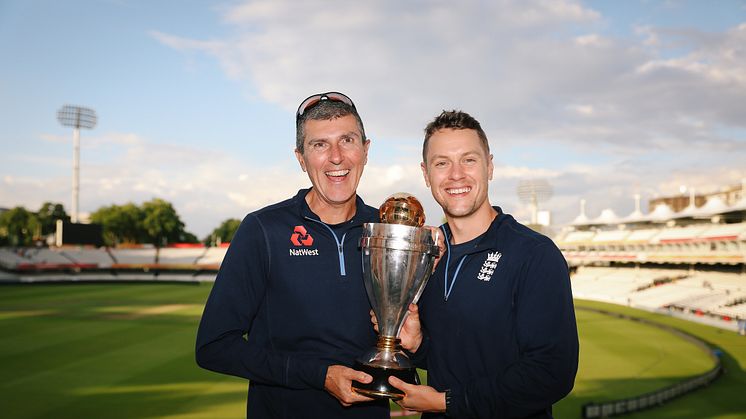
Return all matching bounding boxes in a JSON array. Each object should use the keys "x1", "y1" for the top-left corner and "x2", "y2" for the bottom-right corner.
[{"x1": 0, "y1": 198, "x2": 241, "y2": 247}]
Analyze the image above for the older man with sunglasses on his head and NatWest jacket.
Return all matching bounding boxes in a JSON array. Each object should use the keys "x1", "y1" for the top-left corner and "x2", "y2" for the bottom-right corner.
[{"x1": 196, "y1": 92, "x2": 389, "y2": 418}]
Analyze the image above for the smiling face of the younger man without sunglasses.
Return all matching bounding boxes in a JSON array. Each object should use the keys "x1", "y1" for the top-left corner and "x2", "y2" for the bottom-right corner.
[{"x1": 422, "y1": 128, "x2": 494, "y2": 223}]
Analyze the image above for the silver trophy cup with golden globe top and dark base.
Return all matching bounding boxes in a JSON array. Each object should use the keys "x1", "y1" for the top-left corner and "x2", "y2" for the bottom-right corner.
[{"x1": 352, "y1": 193, "x2": 439, "y2": 400}]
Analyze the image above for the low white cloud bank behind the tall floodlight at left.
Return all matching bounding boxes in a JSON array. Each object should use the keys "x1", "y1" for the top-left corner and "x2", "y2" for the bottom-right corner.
[{"x1": 0, "y1": 133, "x2": 308, "y2": 237}]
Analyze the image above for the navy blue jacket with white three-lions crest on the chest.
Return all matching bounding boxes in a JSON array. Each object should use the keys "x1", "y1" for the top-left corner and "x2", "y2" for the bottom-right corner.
[{"x1": 415, "y1": 207, "x2": 578, "y2": 418}]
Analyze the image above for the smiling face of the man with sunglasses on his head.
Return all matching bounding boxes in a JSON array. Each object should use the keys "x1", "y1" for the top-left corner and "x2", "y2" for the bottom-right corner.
[{"x1": 295, "y1": 115, "x2": 370, "y2": 222}]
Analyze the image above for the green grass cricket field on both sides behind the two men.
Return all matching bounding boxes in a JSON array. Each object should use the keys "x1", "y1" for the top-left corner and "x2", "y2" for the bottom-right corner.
[{"x1": 0, "y1": 284, "x2": 746, "y2": 419}]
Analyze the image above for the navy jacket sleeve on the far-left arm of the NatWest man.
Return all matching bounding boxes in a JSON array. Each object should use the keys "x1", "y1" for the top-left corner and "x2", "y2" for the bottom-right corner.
[{"x1": 196, "y1": 214, "x2": 328, "y2": 389}]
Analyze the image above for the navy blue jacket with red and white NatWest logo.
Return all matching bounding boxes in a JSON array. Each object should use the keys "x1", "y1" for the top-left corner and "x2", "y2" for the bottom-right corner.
[{"x1": 196, "y1": 189, "x2": 389, "y2": 418}]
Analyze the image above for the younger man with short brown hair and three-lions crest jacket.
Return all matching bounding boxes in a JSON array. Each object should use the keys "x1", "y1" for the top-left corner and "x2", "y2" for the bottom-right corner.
[{"x1": 390, "y1": 111, "x2": 578, "y2": 418}]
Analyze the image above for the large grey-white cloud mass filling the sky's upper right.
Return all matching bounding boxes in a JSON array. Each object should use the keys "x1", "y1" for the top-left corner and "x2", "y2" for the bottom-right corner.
[{"x1": 142, "y1": 0, "x2": 746, "y2": 230}]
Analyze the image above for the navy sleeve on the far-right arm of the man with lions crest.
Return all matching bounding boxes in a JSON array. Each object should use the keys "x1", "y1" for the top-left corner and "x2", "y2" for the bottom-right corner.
[{"x1": 448, "y1": 242, "x2": 579, "y2": 418}]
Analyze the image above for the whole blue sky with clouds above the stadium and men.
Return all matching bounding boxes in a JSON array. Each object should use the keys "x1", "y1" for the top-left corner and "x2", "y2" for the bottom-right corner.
[{"x1": 0, "y1": 0, "x2": 746, "y2": 238}]
